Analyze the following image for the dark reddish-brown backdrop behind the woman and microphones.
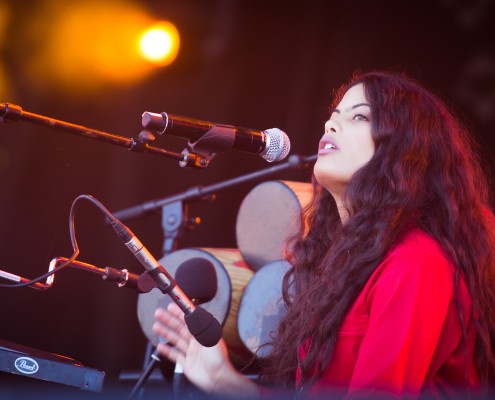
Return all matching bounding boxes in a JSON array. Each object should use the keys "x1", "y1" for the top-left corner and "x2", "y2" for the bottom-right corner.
[{"x1": 0, "y1": 0, "x2": 495, "y2": 396}]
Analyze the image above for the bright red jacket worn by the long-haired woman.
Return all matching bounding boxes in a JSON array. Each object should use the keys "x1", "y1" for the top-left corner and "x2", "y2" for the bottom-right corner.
[{"x1": 297, "y1": 229, "x2": 480, "y2": 398}]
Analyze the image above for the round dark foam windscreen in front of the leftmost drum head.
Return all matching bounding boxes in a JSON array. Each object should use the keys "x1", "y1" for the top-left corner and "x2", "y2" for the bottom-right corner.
[{"x1": 175, "y1": 257, "x2": 218, "y2": 304}]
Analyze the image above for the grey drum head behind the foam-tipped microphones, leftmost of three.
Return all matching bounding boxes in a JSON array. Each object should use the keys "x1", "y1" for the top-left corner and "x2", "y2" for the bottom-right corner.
[{"x1": 137, "y1": 249, "x2": 232, "y2": 346}]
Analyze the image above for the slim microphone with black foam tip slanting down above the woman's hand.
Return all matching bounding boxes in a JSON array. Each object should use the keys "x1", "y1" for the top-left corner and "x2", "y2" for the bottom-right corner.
[{"x1": 111, "y1": 219, "x2": 222, "y2": 347}]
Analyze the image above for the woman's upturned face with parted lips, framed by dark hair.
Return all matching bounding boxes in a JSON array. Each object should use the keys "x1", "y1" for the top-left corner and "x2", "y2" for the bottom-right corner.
[{"x1": 314, "y1": 83, "x2": 375, "y2": 197}]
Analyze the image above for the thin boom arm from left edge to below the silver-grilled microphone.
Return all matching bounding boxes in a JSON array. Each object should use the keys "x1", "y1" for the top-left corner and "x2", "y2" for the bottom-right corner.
[{"x1": 0, "y1": 103, "x2": 209, "y2": 169}]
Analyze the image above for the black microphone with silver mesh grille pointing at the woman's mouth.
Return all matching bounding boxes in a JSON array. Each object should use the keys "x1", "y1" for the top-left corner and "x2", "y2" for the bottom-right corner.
[{"x1": 141, "y1": 111, "x2": 290, "y2": 162}]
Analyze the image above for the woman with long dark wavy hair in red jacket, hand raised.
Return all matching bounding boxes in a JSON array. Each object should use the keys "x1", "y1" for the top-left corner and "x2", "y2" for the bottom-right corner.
[{"x1": 154, "y1": 72, "x2": 495, "y2": 398}]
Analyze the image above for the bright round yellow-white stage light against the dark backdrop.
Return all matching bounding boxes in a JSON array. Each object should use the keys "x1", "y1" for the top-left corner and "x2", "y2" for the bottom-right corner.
[{"x1": 139, "y1": 22, "x2": 180, "y2": 66}]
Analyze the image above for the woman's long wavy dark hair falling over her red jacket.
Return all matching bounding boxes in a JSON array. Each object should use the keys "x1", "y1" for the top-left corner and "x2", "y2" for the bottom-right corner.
[{"x1": 262, "y1": 72, "x2": 495, "y2": 387}]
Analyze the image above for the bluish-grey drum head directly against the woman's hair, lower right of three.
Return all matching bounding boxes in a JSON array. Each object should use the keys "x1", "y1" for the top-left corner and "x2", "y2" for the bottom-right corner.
[{"x1": 237, "y1": 260, "x2": 291, "y2": 358}]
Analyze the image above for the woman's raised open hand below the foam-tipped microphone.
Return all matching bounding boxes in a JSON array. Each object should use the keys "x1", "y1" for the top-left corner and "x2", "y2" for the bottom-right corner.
[{"x1": 153, "y1": 303, "x2": 258, "y2": 397}]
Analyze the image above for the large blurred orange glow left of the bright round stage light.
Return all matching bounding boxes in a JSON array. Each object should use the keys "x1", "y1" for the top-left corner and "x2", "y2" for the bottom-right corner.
[{"x1": 24, "y1": 0, "x2": 180, "y2": 92}]
